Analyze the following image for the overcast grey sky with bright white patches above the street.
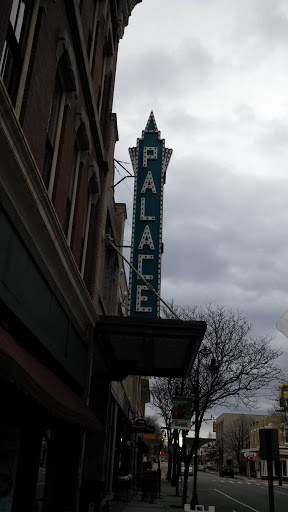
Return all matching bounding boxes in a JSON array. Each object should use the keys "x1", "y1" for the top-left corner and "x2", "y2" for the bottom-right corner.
[{"x1": 113, "y1": 0, "x2": 288, "y2": 432}]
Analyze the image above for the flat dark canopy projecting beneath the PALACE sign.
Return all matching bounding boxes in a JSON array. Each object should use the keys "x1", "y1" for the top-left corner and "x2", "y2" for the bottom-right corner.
[{"x1": 93, "y1": 316, "x2": 207, "y2": 380}]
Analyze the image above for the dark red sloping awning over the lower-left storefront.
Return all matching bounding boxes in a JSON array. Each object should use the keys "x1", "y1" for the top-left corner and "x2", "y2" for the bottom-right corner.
[{"x1": 0, "y1": 326, "x2": 104, "y2": 431}]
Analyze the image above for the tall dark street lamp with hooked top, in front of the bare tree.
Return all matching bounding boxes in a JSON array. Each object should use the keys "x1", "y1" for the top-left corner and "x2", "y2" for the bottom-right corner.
[{"x1": 190, "y1": 348, "x2": 219, "y2": 510}]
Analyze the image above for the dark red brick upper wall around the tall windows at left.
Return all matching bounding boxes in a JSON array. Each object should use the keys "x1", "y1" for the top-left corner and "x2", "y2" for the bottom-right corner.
[{"x1": 0, "y1": 0, "x2": 136, "y2": 312}]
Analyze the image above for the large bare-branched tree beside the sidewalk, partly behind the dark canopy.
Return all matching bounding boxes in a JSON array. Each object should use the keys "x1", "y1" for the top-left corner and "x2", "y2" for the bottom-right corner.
[{"x1": 151, "y1": 302, "x2": 281, "y2": 503}]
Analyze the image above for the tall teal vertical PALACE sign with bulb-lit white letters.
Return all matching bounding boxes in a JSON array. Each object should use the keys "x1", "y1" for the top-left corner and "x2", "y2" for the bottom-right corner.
[{"x1": 129, "y1": 112, "x2": 172, "y2": 318}]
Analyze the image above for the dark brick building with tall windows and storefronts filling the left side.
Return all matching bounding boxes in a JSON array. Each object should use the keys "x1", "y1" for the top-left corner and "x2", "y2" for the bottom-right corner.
[{"x1": 0, "y1": 0, "x2": 146, "y2": 512}]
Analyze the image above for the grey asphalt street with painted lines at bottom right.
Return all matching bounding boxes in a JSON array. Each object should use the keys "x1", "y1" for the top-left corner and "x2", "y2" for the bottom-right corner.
[{"x1": 188, "y1": 471, "x2": 288, "y2": 512}]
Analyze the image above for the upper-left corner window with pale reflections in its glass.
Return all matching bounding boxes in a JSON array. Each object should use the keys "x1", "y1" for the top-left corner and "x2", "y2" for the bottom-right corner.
[{"x1": 0, "y1": 0, "x2": 31, "y2": 105}]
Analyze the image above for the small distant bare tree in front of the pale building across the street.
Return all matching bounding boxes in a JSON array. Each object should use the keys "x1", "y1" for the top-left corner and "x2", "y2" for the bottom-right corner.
[{"x1": 224, "y1": 414, "x2": 250, "y2": 470}]
